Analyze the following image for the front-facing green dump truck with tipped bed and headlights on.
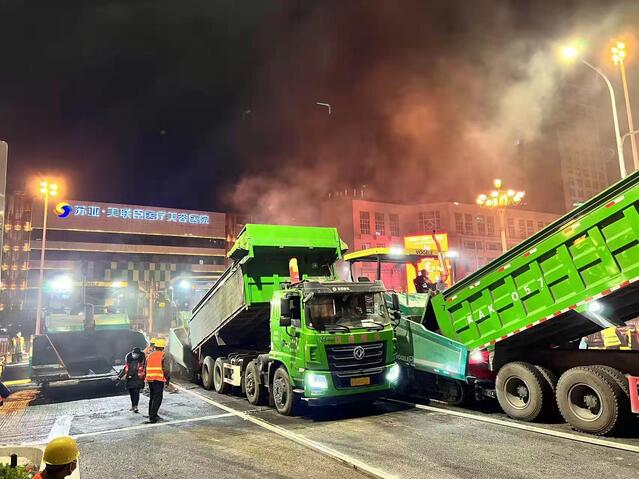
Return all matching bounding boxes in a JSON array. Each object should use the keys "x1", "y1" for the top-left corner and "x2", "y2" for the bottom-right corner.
[{"x1": 169, "y1": 224, "x2": 399, "y2": 415}]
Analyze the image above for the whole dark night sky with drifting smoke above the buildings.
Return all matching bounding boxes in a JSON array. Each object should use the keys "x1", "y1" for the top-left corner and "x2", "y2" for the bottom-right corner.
[{"x1": 0, "y1": 0, "x2": 639, "y2": 217}]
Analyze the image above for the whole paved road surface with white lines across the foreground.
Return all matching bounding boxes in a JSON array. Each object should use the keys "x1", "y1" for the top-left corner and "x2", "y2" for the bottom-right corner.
[{"x1": 0, "y1": 383, "x2": 639, "y2": 479}]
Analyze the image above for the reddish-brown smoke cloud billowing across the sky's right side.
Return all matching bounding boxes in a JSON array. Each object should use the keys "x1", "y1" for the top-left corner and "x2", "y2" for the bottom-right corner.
[{"x1": 226, "y1": 1, "x2": 636, "y2": 223}]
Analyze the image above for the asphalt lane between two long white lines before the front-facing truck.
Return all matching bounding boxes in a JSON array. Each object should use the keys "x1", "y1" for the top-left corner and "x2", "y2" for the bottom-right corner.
[{"x1": 181, "y1": 386, "x2": 639, "y2": 479}]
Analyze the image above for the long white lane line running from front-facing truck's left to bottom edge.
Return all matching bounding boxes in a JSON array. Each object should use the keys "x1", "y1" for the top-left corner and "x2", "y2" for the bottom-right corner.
[{"x1": 174, "y1": 384, "x2": 398, "y2": 479}]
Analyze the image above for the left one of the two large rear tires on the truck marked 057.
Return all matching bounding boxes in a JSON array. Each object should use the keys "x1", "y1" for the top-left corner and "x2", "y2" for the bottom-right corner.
[{"x1": 495, "y1": 361, "x2": 552, "y2": 421}]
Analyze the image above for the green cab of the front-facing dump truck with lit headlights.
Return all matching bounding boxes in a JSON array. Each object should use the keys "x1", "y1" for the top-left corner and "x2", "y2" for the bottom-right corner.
[{"x1": 269, "y1": 281, "x2": 398, "y2": 404}]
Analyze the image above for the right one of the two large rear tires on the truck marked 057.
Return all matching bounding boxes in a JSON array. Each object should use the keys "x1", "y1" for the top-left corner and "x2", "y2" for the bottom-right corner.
[{"x1": 557, "y1": 366, "x2": 624, "y2": 436}]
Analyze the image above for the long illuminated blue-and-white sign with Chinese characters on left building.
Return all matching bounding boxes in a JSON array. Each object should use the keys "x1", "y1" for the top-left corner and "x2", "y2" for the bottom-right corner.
[{"x1": 60, "y1": 203, "x2": 210, "y2": 225}]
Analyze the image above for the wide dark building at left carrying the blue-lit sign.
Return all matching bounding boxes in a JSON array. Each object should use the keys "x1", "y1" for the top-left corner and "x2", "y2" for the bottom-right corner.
[{"x1": 0, "y1": 194, "x2": 248, "y2": 330}]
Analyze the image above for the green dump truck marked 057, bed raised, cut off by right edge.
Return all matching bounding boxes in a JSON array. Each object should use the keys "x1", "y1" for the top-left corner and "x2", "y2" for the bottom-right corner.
[{"x1": 348, "y1": 172, "x2": 639, "y2": 434}]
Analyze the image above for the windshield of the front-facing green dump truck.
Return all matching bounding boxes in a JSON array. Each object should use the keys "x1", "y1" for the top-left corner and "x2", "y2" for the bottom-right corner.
[{"x1": 306, "y1": 293, "x2": 391, "y2": 331}]
